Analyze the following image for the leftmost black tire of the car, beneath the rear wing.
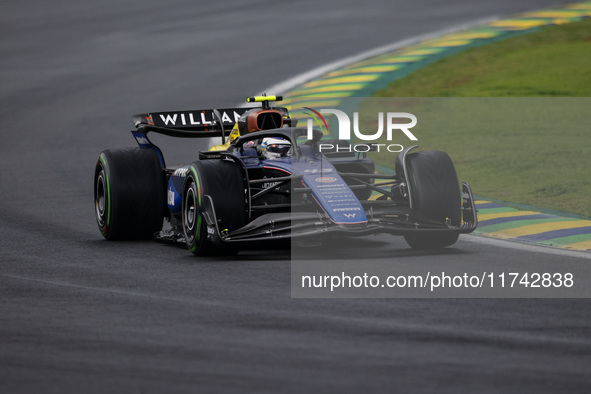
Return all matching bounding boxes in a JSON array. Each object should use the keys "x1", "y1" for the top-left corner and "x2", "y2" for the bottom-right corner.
[{"x1": 94, "y1": 148, "x2": 166, "y2": 240}]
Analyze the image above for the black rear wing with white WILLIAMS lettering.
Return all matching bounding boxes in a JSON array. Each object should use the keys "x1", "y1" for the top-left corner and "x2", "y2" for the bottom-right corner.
[{"x1": 133, "y1": 108, "x2": 251, "y2": 138}]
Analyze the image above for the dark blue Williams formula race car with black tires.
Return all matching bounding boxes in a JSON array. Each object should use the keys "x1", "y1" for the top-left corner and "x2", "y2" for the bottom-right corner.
[{"x1": 94, "y1": 96, "x2": 477, "y2": 255}]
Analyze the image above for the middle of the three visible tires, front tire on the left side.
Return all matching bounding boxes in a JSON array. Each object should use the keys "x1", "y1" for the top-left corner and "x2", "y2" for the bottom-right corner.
[{"x1": 182, "y1": 160, "x2": 246, "y2": 256}]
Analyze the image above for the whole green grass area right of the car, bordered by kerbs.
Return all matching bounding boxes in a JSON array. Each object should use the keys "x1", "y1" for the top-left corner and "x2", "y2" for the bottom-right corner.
[{"x1": 376, "y1": 19, "x2": 591, "y2": 217}]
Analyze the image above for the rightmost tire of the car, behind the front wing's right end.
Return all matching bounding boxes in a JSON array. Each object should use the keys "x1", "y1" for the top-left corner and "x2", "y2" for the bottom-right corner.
[{"x1": 404, "y1": 151, "x2": 462, "y2": 250}]
